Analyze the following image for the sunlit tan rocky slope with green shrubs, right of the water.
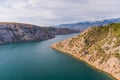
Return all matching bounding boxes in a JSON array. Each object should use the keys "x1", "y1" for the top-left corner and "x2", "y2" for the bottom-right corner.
[{"x1": 51, "y1": 23, "x2": 120, "y2": 80}]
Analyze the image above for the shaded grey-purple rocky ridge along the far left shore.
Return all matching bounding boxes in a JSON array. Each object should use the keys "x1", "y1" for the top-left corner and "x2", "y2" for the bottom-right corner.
[{"x1": 0, "y1": 22, "x2": 79, "y2": 44}]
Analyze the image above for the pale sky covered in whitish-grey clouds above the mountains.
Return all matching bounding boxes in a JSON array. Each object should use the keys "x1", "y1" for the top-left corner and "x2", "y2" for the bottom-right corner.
[{"x1": 0, "y1": 0, "x2": 120, "y2": 26}]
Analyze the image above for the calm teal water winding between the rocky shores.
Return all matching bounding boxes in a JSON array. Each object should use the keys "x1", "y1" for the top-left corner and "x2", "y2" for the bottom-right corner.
[{"x1": 0, "y1": 34, "x2": 115, "y2": 80}]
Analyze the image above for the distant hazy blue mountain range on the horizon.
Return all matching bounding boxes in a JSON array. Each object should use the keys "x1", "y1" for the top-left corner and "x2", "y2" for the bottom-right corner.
[{"x1": 54, "y1": 18, "x2": 120, "y2": 30}]
